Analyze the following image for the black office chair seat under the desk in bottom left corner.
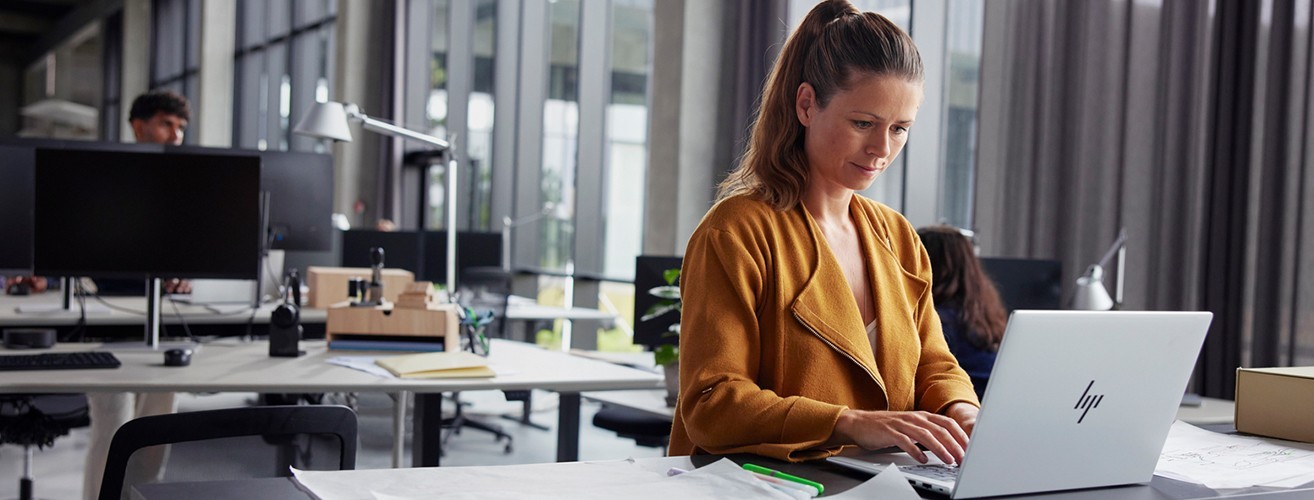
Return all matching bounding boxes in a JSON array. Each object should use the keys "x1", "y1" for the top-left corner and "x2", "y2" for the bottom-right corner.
[{"x1": 0, "y1": 394, "x2": 91, "y2": 500}]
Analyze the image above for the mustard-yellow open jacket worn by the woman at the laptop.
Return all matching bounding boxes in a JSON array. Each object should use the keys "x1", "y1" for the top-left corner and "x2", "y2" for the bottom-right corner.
[{"x1": 670, "y1": 194, "x2": 980, "y2": 461}]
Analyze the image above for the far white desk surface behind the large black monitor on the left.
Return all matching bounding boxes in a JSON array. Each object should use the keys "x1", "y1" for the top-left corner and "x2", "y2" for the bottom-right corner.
[{"x1": 0, "y1": 293, "x2": 329, "y2": 327}]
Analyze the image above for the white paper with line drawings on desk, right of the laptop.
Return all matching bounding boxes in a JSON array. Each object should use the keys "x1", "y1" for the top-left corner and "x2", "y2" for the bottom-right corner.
[{"x1": 1154, "y1": 420, "x2": 1314, "y2": 490}]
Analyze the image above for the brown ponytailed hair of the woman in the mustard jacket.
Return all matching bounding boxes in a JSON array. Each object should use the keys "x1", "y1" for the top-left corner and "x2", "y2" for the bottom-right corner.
[{"x1": 716, "y1": 0, "x2": 922, "y2": 210}]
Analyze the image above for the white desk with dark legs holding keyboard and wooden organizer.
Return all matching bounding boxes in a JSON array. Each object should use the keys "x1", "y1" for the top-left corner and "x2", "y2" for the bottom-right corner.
[{"x1": 0, "y1": 340, "x2": 662, "y2": 466}]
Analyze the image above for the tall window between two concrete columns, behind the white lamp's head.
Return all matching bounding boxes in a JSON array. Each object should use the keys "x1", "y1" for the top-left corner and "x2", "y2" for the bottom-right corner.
[{"x1": 233, "y1": 0, "x2": 338, "y2": 151}]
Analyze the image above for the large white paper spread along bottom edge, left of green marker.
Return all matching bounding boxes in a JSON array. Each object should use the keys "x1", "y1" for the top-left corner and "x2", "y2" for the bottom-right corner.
[{"x1": 293, "y1": 459, "x2": 790, "y2": 500}]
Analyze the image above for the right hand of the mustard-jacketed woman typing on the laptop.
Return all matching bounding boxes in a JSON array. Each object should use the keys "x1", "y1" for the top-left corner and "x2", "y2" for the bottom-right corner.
[{"x1": 830, "y1": 409, "x2": 967, "y2": 463}]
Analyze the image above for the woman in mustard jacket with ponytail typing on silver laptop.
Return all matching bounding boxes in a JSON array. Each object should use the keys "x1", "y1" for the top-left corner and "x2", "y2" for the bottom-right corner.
[{"x1": 670, "y1": 0, "x2": 979, "y2": 463}]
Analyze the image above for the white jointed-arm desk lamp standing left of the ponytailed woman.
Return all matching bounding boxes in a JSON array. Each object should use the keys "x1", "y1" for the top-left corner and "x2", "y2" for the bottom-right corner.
[{"x1": 292, "y1": 101, "x2": 457, "y2": 297}]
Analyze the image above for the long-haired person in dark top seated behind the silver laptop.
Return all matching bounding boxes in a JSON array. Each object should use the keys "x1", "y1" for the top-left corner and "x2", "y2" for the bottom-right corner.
[{"x1": 917, "y1": 226, "x2": 1008, "y2": 398}]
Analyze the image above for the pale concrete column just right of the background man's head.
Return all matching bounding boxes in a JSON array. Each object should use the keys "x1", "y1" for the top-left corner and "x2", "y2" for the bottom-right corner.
[{"x1": 194, "y1": 0, "x2": 238, "y2": 147}]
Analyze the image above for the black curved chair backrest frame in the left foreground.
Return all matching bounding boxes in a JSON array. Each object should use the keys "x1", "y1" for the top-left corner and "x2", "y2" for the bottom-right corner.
[{"x1": 100, "y1": 406, "x2": 356, "y2": 500}]
